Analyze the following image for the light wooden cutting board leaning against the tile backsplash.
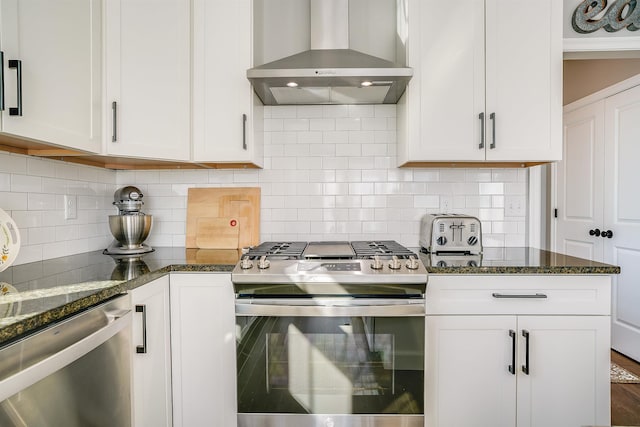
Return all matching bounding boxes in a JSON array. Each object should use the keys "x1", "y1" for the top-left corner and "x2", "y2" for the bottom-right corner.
[{"x1": 185, "y1": 187, "x2": 260, "y2": 249}]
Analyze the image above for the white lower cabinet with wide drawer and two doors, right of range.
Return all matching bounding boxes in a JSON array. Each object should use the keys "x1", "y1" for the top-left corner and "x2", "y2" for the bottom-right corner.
[{"x1": 425, "y1": 275, "x2": 611, "y2": 427}]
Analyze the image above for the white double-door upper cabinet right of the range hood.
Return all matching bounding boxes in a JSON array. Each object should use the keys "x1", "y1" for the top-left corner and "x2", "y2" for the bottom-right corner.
[{"x1": 398, "y1": 0, "x2": 562, "y2": 165}]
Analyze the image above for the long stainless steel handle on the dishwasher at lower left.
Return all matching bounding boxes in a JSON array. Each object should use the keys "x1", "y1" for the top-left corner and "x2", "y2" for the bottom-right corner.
[{"x1": 0, "y1": 309, "x2": 133, "y2": 401}]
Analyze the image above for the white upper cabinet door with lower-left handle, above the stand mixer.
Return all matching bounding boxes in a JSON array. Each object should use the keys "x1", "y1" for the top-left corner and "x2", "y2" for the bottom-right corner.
[{"x1": 104, "y1": 0, "x2": 189, "y2": 160}]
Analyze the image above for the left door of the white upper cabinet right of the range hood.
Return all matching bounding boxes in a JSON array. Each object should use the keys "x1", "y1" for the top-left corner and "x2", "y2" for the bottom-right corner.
[{"x1": 406, "y1": 0, "x2": 485, "y2": 161}]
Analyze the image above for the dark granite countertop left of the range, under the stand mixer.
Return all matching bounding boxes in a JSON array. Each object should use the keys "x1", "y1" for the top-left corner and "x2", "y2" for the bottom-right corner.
[{"x1": 0, "y1": 248, "x2": 239, "y2": 347}]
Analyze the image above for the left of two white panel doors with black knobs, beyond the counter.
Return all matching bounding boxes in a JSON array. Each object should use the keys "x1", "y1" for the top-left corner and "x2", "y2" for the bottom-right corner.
[{"x1": 554, "y1": 101, "x2": 604, "y2": 261}]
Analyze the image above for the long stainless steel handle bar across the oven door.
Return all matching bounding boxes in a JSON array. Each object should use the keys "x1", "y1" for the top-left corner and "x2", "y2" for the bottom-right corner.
[{"x1": 236, "y1": 298, "x2": 426, "y2": 317}]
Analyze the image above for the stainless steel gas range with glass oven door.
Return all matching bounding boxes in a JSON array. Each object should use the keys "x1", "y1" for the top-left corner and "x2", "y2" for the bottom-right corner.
[{"x1": 232, "y1": 241, "x2": 427, "y2": 427}]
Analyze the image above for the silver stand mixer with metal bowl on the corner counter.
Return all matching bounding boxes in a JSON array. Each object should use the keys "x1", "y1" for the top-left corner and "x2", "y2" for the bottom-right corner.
[{"x1": 104, "y1": 186, "x2": 153, "y2": 256}]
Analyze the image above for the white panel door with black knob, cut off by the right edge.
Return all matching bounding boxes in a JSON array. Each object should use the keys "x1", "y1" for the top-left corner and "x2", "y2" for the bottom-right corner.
[{"x1": 603, "y1": 86, "x2": 640, "y2": 361}]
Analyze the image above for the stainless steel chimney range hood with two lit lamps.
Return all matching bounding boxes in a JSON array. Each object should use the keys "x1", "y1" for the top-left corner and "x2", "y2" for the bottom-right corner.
[{"x1": 247, "y1": 0, "x2": 413, "y2": 105}]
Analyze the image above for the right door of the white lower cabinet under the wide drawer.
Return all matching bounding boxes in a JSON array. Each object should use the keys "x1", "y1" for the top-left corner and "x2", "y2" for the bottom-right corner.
[{"x1": 516, "y1": 316, "x2": 611, "y2": 427}]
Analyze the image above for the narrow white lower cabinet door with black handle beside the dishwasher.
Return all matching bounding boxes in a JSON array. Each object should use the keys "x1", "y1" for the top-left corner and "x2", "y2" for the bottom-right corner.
[{"x1": 131, "y1": 275, "x2": 172, "y2": 427}]
